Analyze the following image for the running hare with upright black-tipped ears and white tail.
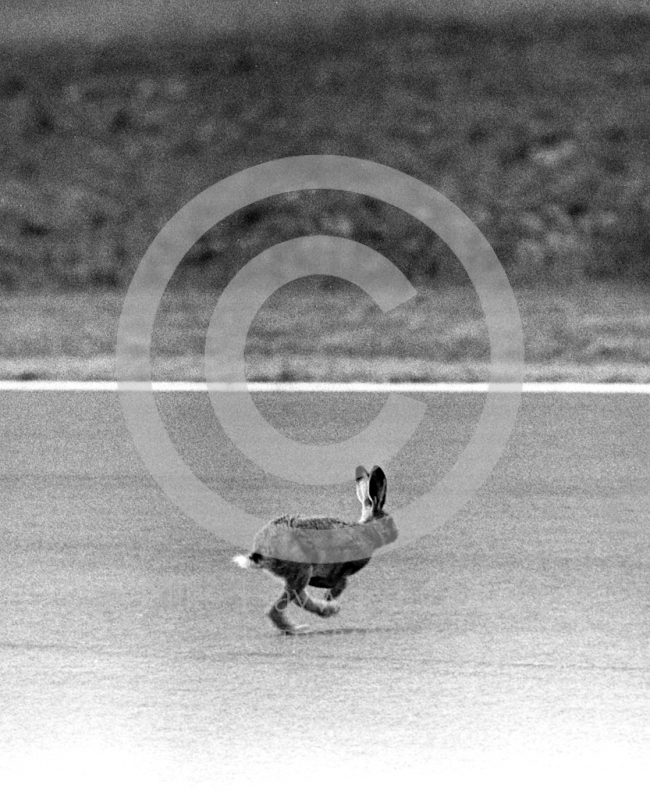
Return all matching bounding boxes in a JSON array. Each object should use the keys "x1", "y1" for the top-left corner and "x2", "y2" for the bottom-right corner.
[{"x1": 233, "y1": 467, "x2": 397, "y2": 634}]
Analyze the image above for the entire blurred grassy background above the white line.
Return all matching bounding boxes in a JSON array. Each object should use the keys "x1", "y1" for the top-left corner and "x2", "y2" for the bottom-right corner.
[{"x1": 0, "y1": 0, "x2": 650, "y2": 380}]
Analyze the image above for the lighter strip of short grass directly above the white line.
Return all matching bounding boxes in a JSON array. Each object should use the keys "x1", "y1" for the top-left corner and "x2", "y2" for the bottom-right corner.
[{"x1": 0, "y1": 281, "x2": 650, "y2": 382}]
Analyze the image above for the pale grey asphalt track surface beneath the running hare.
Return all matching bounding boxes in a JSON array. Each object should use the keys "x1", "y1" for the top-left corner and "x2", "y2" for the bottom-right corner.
[{"x1": 0, "y1": 392, "x2": 650, "y2": 797}]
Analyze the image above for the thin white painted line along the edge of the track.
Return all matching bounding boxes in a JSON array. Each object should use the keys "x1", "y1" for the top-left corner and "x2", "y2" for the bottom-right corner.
[{"x1": 0, "y1": 381, "x2": 650, "y2": 394}]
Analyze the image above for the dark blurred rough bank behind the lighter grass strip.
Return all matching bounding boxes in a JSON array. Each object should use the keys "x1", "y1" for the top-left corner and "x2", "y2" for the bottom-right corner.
[{"x1": 0, "y1": 14, "x2": 650, "y2": 292}]
